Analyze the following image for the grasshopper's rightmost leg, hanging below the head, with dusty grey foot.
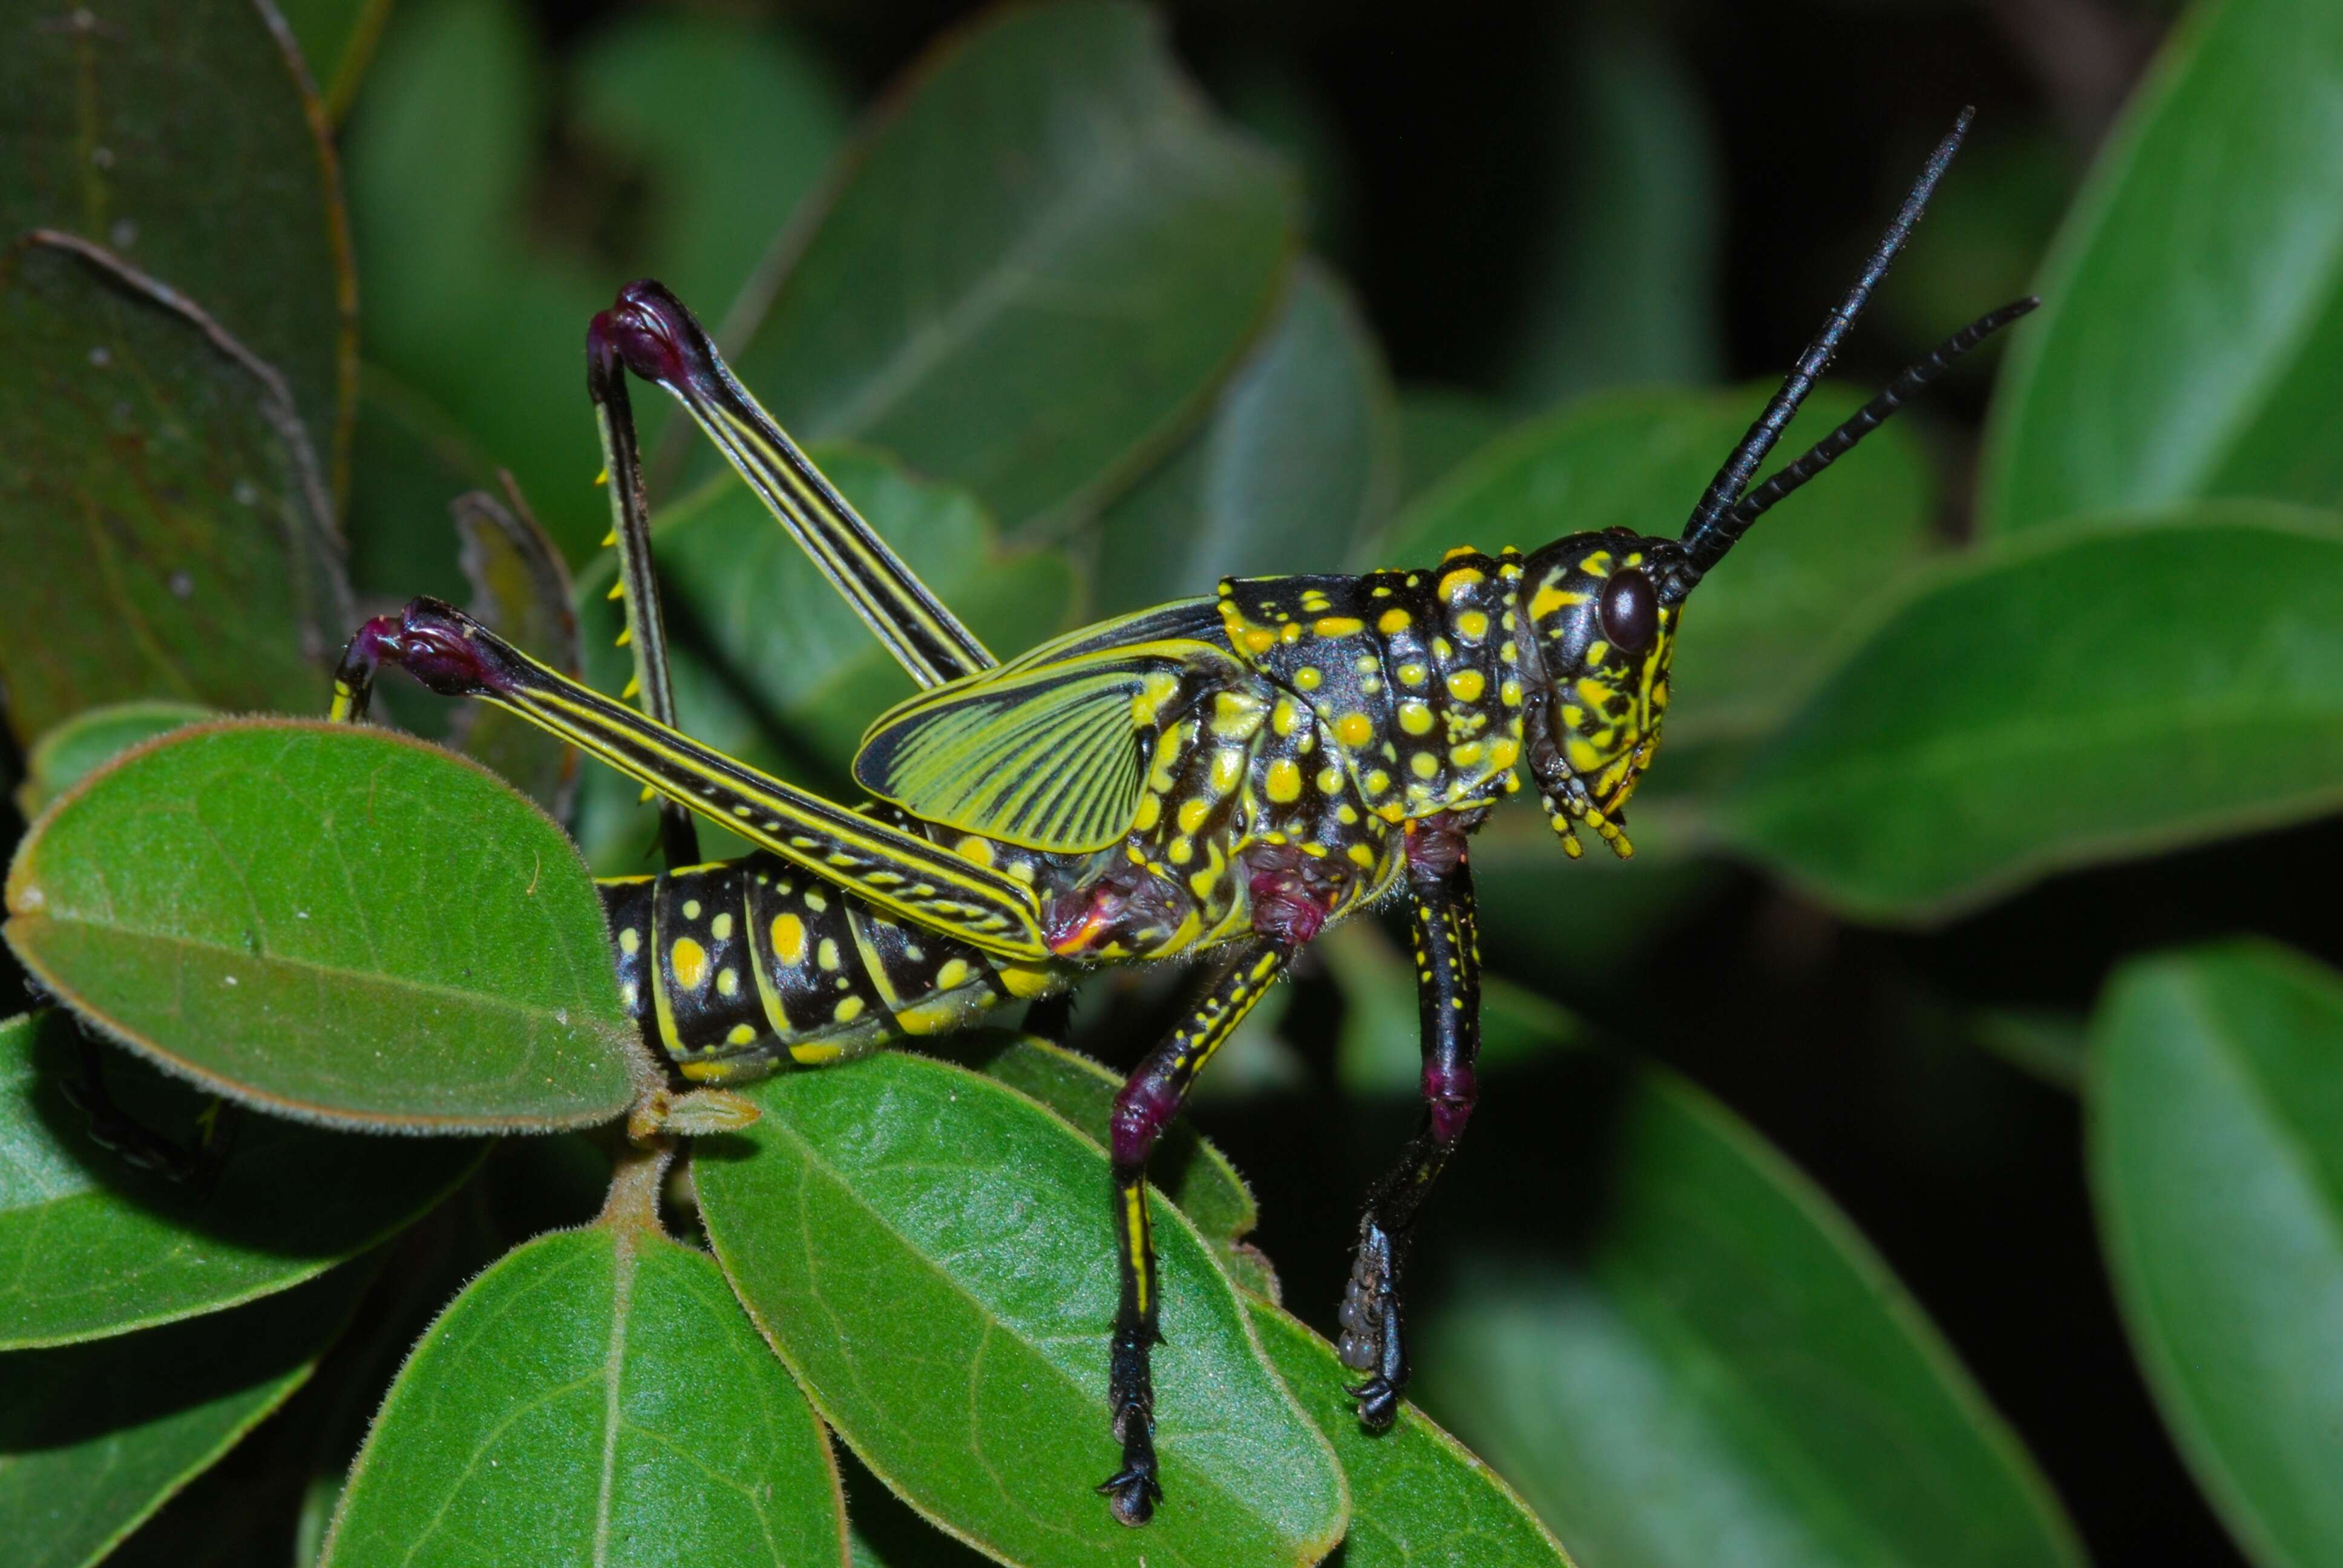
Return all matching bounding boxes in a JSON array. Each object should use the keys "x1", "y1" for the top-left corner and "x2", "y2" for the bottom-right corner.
[{"x1": 1338, "y1": 849, "x2": 1481, "y2": 1432}]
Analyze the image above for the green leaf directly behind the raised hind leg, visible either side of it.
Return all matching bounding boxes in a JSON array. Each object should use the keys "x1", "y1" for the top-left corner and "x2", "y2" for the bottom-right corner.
[{"x1": 577, "y1": 448, "x2": 1075, "y2": 874}]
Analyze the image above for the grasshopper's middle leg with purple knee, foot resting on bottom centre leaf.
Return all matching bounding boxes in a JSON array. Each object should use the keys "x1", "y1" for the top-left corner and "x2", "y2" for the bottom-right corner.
[{"x1": 1099, "y1": 940, "x2": 1293, "y2": 1523}]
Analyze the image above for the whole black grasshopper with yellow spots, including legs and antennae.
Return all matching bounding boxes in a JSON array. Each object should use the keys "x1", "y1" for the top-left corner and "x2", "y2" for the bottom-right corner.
[{"x1": 321, "y1": 115, "x2": 2031, "y2": 1523}]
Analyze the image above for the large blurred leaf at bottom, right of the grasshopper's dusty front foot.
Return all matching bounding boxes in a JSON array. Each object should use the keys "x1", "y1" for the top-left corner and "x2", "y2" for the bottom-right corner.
[{"x1": 1418, "y1": 1073, "x2": 2083, "y2": 1568}]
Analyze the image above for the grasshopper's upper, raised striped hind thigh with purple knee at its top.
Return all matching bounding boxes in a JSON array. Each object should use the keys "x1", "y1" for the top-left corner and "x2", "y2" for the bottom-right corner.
[{"x1": 595, "y1": 279, "x2": 996, "y2": 684}]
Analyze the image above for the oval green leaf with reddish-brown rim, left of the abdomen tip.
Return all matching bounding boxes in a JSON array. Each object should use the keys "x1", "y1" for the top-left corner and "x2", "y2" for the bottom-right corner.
[{"x1": 5, "y1": 719, "x2": 640, "y2": 1132}]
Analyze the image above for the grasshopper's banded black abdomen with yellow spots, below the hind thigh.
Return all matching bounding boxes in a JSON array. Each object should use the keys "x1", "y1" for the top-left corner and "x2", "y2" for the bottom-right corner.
[{"x1": 600, "y1": 855, "x2": 1071, "y2": 1083}]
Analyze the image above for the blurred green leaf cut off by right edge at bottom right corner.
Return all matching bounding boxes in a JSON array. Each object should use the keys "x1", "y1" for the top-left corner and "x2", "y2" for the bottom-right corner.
[{"x1": 2088, "y1": 944, "x2": 2343, "y2": 1568}]
